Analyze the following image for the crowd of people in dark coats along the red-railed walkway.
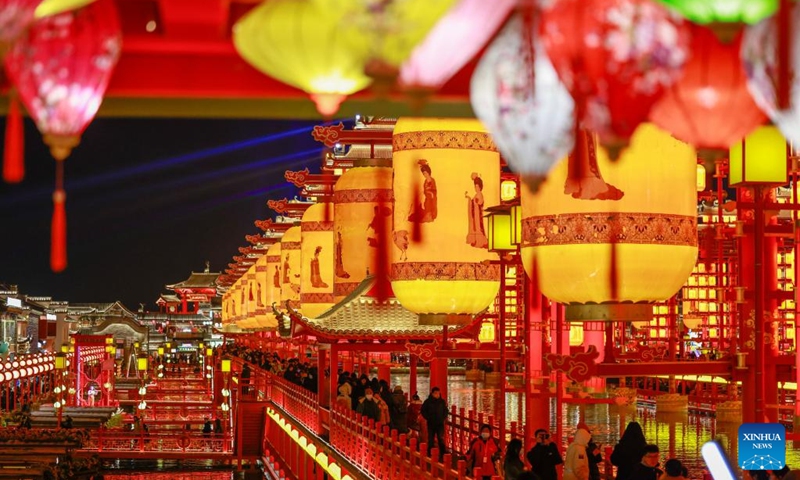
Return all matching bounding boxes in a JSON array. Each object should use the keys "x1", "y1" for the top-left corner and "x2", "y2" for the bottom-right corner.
[{"x1": 226, "y1": 345, "x2": 800, "y2": 480}]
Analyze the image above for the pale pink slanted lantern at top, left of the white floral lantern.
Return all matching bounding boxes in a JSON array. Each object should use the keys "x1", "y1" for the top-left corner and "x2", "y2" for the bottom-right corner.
[{"x1": 400, "y1": 0, "x2": 517, "y2": 92}]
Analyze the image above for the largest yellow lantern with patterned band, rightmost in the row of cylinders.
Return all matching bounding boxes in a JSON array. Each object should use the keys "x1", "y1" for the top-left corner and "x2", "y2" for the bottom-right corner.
[{"x1": 522, "y1": 124, "x2": 697, "y2": 320}]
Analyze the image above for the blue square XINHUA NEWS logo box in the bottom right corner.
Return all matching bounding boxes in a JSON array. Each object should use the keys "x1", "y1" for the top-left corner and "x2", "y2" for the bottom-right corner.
[{"x1": 739, "y1": 423, "x2": 786, "y2": 470}]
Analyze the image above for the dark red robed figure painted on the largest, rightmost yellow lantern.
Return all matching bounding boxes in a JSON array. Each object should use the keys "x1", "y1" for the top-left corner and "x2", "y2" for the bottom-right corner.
[{"x1": 564, "y1": 130, "x2": 625, "y2": 200}]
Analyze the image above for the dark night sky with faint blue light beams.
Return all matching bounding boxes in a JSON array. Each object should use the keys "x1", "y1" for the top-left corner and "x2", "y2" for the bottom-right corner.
[{"x1": 0, "y1": 118, "x2": 332, "y2": 310}]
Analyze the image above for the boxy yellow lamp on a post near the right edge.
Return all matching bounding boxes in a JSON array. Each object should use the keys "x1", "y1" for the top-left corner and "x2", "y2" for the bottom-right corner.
[{"x1": 729, "y1": 126, "x2": 789, "y2": 187}]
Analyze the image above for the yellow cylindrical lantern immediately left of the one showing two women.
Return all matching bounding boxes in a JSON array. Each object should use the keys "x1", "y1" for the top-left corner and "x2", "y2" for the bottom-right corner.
[{"x1": 333, "y1": 163, "x2": 392, "y2": 302}]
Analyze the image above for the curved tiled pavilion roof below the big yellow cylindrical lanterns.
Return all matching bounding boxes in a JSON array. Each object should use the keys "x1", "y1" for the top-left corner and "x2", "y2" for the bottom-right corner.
[{"x1": 289, "y1": 277, "x2": 469, "y2": 340}]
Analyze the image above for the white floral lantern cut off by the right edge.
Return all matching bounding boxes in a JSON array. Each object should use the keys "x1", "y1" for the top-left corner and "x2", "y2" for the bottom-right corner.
[{"x1": 741, "y1": 7, "x2": 800, "y2": 143}]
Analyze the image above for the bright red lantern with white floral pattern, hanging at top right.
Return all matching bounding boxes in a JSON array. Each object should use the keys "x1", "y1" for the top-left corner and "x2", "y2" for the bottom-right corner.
[{"x1": 542, "y1": 0, "x2": 689, "y2": 152}]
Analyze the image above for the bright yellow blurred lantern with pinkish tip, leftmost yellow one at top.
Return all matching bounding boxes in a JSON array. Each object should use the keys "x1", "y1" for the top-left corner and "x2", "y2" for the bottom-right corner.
[{"x1": 233, "y1": 0, "x2": 370, "y2": 117}]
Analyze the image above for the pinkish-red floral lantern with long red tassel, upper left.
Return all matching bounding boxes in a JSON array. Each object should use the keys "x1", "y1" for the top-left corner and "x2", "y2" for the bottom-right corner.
[{"x1": 5, "y1": 0, "x2": 122, "y2": 272}]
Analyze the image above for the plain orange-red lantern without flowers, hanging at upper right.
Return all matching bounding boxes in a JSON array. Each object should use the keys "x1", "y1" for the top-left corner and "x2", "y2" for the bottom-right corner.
[{"x1": 650, "y1": 26, "x2": 766, "y2": 156}]
